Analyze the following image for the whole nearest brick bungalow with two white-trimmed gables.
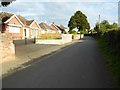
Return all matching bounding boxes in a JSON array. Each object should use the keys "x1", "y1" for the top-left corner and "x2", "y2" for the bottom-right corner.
[{"x1": 0, "y1": 12, "x2": 40, "y2": 40}]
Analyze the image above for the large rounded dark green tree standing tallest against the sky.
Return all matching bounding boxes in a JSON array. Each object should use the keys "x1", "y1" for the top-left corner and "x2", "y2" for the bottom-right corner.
[{"x1": 68, "y1": 11, "x2": 90, "y2": 31}]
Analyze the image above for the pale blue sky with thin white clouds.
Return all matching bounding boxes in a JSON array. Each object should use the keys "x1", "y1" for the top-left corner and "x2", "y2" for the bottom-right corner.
[{"x1": 0, "y1": 0, "x2": 119, "y2": 27}]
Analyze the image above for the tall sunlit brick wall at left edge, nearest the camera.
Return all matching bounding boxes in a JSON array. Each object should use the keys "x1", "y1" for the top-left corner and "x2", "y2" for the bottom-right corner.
[{"x1": 0, "y1": 33, "x2": 15, "y2": 63}]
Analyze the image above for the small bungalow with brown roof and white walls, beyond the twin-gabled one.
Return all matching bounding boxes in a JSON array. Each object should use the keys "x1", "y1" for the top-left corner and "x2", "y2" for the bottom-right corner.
[{"x1": 39, "y1": 22, "x2": 56, "y2": 34}]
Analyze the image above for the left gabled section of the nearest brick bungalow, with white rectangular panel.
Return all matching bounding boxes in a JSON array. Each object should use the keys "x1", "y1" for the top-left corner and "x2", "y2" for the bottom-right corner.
[{"x1": 0, "y1": 12, "x2": 24, "y2": 39}]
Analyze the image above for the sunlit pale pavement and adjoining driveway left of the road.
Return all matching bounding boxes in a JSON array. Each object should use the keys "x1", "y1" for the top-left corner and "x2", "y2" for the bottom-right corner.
[{"x1": 2, "y1": 40, "x2": 77, "y2": 77}]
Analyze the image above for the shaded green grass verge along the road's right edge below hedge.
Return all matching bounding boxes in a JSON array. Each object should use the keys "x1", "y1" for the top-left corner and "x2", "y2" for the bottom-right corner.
[{"x1": 97, "y1": 38, "x2": 120, "y2": 88}]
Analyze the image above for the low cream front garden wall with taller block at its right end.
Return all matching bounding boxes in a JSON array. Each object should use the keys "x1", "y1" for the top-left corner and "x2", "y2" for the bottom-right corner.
[{"x1": 36, "y1": 34, "x2": 72, "y2": 45}]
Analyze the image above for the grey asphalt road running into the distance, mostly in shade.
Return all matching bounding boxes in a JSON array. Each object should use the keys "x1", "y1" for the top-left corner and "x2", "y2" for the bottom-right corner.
[{"x1": 3, "y1": 37, "x2": 115, "y2": 88}]
